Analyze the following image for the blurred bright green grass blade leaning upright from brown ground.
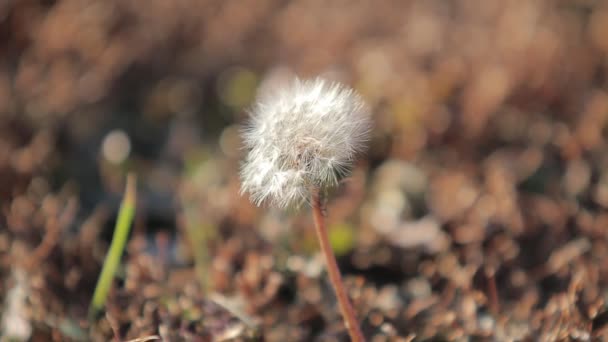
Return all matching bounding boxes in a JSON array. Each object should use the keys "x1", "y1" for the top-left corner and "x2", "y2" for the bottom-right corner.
[{"x1": 89, "y1": 174, "x2": 137, "y2": 319}]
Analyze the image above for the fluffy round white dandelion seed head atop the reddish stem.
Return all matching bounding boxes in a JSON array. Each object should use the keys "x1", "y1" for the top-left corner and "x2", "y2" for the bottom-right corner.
[{"x1": 241, "y1": 78, "x2": 371, "y2": 207}]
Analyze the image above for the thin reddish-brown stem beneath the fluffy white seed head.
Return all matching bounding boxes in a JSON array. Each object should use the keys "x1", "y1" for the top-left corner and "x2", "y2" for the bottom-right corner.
[{"x1": 312, "y1": 188, "x2": 365, "y2": 342}]
